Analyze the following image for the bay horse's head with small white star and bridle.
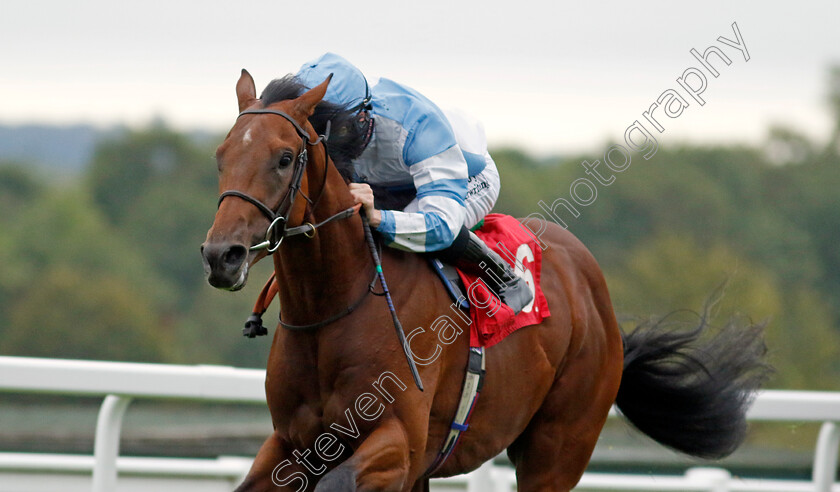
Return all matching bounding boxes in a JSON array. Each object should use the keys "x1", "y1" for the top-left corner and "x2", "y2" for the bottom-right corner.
[{"x1": 201, "y1": 70, "x2": 330, "y2": 290}]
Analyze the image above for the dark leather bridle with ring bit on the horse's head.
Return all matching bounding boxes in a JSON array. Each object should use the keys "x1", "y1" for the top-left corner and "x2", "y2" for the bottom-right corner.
[{"x1": 217, "y1": 109, "x2": 360, "y2": 254}]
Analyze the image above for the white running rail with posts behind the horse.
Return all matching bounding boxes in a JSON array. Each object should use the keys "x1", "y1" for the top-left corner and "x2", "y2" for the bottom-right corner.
[{"x1": 0, "y1": 356, "x2": 840, "y2": 492}]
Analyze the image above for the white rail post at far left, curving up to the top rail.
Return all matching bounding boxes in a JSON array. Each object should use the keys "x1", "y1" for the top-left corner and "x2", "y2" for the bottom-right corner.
[{"x1": 93, "y1": 395, "x2": 131, "y2": 492}]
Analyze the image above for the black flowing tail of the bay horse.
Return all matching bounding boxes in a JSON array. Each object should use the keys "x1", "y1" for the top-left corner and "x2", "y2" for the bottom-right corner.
[{"x1": 616, "y1": 311, "x2": 772, "y2": 459}]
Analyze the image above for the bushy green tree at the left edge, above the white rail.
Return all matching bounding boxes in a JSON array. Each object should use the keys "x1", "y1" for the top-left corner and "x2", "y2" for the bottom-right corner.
[{"x1": 0, "y1": 185, "x2": 171, "y2": 360}]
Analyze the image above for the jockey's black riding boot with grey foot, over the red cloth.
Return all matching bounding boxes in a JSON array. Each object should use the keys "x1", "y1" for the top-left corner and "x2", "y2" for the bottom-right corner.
[{"x1": 437, "y1": 227, "x2": 534, "y2": 314}]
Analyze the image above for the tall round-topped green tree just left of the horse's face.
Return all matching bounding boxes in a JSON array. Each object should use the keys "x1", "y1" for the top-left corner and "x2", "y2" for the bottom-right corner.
[{"x1": 88, "y1": 123, "x2": 218, "y2": 309}]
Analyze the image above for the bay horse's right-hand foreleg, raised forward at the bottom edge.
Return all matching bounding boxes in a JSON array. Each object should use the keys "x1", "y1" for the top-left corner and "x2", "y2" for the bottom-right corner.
[{"x1": 315, "y1": 419, "x2": 411, "y2": 492}]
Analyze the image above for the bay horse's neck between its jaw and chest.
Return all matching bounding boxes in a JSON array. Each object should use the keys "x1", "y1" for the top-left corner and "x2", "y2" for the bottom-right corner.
[{"x1": 274, "y1": 154, "x2": 374, "y2": 324}]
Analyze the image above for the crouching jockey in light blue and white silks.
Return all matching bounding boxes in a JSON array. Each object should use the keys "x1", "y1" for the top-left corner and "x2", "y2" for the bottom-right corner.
[{"x1": 297, "y1": 53, "x2": 533, "y2": 313}]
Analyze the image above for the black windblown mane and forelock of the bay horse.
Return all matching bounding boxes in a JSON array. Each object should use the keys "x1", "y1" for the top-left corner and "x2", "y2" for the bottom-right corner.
[{"x1": 260, "y1": 74, "x2": 365, "y2": 181}]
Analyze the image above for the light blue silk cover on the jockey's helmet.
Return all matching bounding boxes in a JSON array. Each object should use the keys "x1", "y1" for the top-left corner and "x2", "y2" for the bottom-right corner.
[{"x1": 297, "y1": 53, "x2": 367, "y2": 107}]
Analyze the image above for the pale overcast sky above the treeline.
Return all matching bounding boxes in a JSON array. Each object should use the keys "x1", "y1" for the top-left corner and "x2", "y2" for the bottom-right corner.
[{"x1": 0, "y1": 0, "x2": 840, "y2": 153}]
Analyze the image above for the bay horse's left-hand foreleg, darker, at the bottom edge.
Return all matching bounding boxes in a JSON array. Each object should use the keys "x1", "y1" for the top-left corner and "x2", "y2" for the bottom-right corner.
[{"x1": 234, "y1": 434, "x2": 312, "y2": 492}]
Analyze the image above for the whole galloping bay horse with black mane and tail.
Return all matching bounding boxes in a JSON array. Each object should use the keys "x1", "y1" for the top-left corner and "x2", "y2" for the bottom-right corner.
[{"x1": 202, "y1": 70, "x2": 766, "y2": 492}]
